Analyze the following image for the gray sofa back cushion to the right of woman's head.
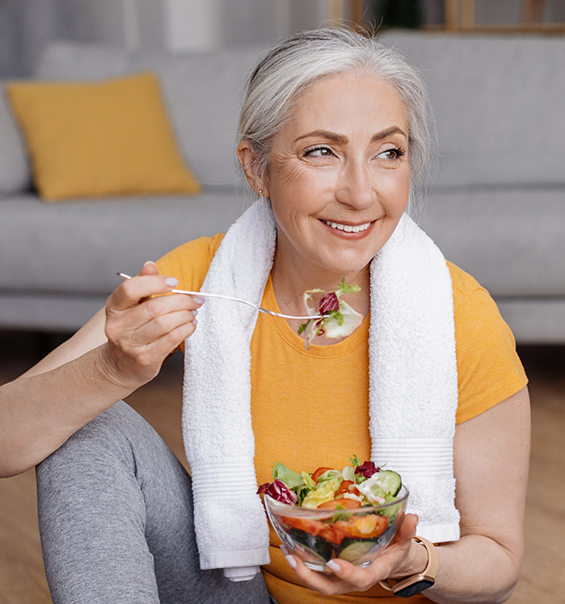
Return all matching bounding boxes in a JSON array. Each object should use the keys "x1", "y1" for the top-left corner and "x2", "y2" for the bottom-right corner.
[{"x1": 378, "y1": 33, "x2": 565, "y2": 185}]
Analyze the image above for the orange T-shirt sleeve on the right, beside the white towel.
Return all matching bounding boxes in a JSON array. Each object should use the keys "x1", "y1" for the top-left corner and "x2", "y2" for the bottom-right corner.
[{"x1": 448, "y1": 263, "x2": 528, "y2": 423}]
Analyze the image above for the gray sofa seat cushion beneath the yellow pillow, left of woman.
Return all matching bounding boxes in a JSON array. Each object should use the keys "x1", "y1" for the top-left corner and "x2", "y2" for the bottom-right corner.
[{"x1": 0, "y1": 192, "x2": 244, "y2": 295}]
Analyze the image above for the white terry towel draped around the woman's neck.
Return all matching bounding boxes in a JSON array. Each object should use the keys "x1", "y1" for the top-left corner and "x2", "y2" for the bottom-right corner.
[{"x1": 183, "y1": 199, "x2": 459, "y2": 580}]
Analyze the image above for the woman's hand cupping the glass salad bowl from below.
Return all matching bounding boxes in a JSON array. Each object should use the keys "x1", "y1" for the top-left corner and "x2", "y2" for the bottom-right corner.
[{"x1": 281, "y1": 514, "x2": 427, "y2": 596}]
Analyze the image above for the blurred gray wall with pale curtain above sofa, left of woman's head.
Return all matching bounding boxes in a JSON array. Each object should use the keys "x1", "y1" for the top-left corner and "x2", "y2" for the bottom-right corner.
[{"x1": 0, "y1": 0, "x2": 330, "y2": 77}]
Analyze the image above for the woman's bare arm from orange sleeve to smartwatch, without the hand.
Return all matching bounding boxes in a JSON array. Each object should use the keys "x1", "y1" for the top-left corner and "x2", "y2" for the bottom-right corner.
[{"x1": 426, "y1": 388, "x2": 530, "y2": 604}]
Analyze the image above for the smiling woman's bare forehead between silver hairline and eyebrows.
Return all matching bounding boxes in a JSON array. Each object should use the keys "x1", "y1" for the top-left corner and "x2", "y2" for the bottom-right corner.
[{"x1": 287, "y1": 72, "x2": 408, "y2": 133}]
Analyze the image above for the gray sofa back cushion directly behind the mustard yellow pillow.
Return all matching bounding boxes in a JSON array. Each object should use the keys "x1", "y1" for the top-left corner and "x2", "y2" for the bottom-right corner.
[{"x1": 36, "y1": 43, "x2": 268, "y2": 192}]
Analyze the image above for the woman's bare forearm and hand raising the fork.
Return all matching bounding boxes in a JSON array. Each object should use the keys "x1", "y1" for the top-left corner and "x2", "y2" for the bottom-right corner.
[{"x1": 0, "y1": 263, "x2": 200, "y2": 477}]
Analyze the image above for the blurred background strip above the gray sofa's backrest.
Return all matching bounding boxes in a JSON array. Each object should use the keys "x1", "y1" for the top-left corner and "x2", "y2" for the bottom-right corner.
[{"x1": 0, "y1": 0, "x2": 565, "y2": 77}]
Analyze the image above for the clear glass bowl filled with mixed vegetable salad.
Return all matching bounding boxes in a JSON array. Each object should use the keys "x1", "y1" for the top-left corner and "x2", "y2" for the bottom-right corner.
[{"x1": 258, "y1": 456, "x2": 408, "y2": 572}]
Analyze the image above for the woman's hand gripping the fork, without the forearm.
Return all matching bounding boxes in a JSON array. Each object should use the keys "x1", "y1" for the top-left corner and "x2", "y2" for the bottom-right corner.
[{"x1": 104, "y1": 262, "x2": 204, "y2": 388}]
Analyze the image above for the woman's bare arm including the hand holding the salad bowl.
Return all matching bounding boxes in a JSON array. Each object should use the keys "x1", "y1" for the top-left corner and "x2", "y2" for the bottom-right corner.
[{"x1": 282, "y1": 388, "x2": 530, "y2": 604}]
